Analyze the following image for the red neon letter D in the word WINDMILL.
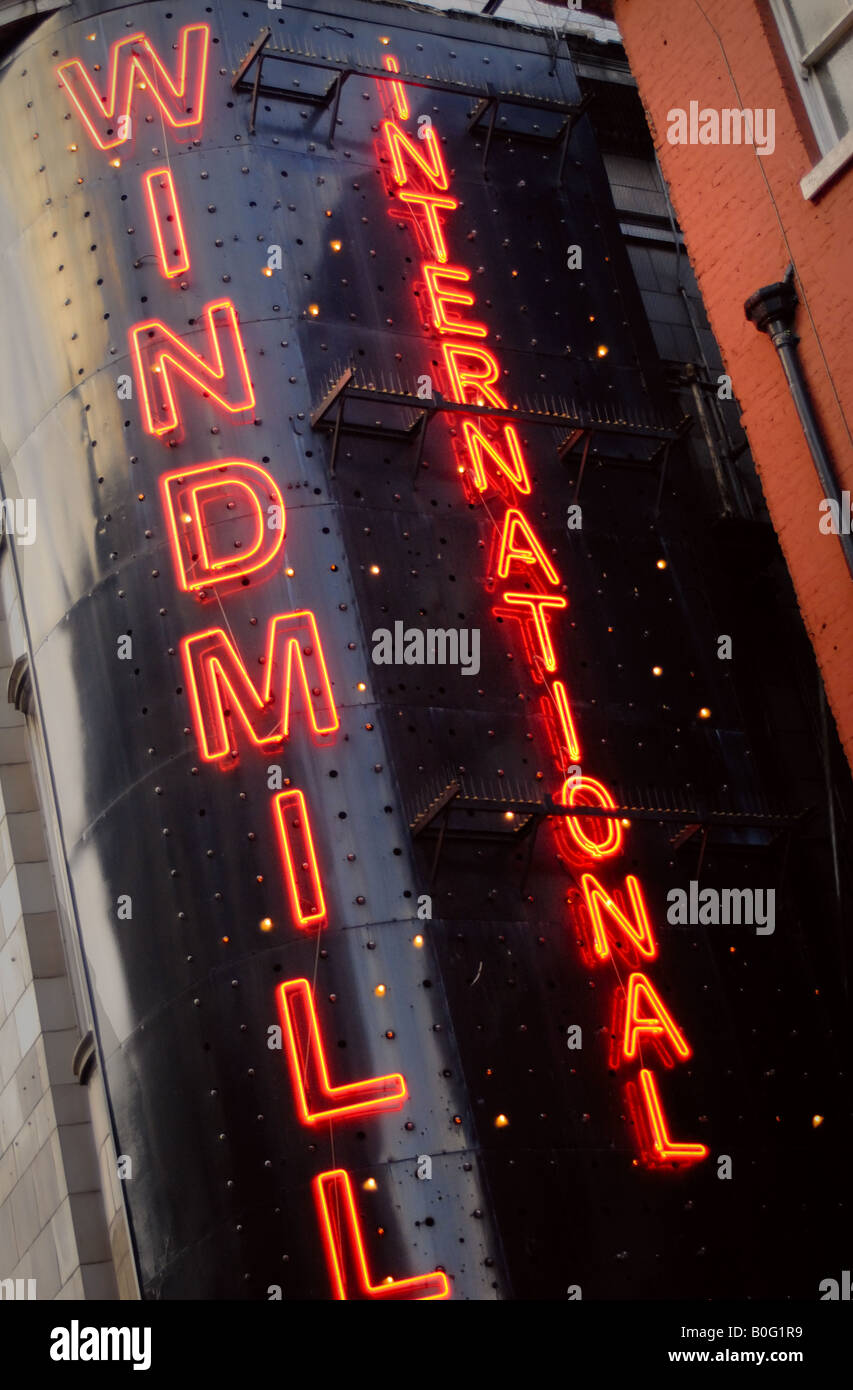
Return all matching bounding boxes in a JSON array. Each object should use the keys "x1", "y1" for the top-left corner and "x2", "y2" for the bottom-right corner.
[{"x1": 160, "y1": 459, "x2": 285, "y2": 591}]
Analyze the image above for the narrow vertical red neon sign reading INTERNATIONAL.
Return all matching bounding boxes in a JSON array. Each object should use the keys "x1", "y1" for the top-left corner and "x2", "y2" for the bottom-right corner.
[{"x1": 378, "y1": 54, "x2": 709, "y2": 1166}]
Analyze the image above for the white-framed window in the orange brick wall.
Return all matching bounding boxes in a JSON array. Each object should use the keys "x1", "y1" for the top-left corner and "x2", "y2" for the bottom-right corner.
[{"x1": 771, "y1": 0, "x2": 853, "y2": 197}]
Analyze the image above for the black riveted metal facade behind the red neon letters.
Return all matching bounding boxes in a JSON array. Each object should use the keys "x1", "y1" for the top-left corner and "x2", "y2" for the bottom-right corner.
[{"x1": 0, "y1": 0, "x2": 846, "y2": 1300}]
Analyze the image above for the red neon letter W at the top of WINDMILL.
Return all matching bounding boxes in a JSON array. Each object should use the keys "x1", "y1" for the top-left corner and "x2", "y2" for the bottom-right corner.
[{"x1": 56, "y1": 24, "x2": 210, "y2": 150}]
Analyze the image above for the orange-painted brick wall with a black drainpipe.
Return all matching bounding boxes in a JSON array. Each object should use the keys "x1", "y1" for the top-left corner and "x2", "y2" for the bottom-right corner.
[{"x1": 613, "y1": 0, "x2": 853, "y2": 765}]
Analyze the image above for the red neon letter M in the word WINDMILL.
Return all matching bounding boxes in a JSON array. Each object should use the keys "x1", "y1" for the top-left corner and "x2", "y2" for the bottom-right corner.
[{"x1": 181, "y1": 609, "x2": 339, "y2": 762}]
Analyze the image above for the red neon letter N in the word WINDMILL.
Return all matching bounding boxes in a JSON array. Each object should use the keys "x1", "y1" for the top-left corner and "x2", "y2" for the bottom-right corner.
[{"x1": 129, "y1": 299, "x2": 254, "y2": 435}]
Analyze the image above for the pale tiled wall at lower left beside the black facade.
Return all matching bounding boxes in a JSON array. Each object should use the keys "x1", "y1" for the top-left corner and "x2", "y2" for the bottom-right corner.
[{"x1": 0, "y1": 546, "x2": 139, "y2": 1300}]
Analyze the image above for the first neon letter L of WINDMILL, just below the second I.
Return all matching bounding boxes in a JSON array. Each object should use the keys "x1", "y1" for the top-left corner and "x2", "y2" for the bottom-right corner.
[{"x1": 275, "y1": 980, "x2": 406, "y2": 1125}]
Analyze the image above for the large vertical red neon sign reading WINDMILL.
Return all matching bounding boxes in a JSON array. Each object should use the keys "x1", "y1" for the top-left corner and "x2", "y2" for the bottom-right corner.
[{"x1": 57, "y1": 24, "x2": 450, "y2": 1300}]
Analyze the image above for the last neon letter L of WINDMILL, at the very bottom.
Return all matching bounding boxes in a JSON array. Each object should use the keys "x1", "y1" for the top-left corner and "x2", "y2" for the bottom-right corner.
[{"x1": 313, "y1": 1168, "x2": 450, "y2": 1301}]
